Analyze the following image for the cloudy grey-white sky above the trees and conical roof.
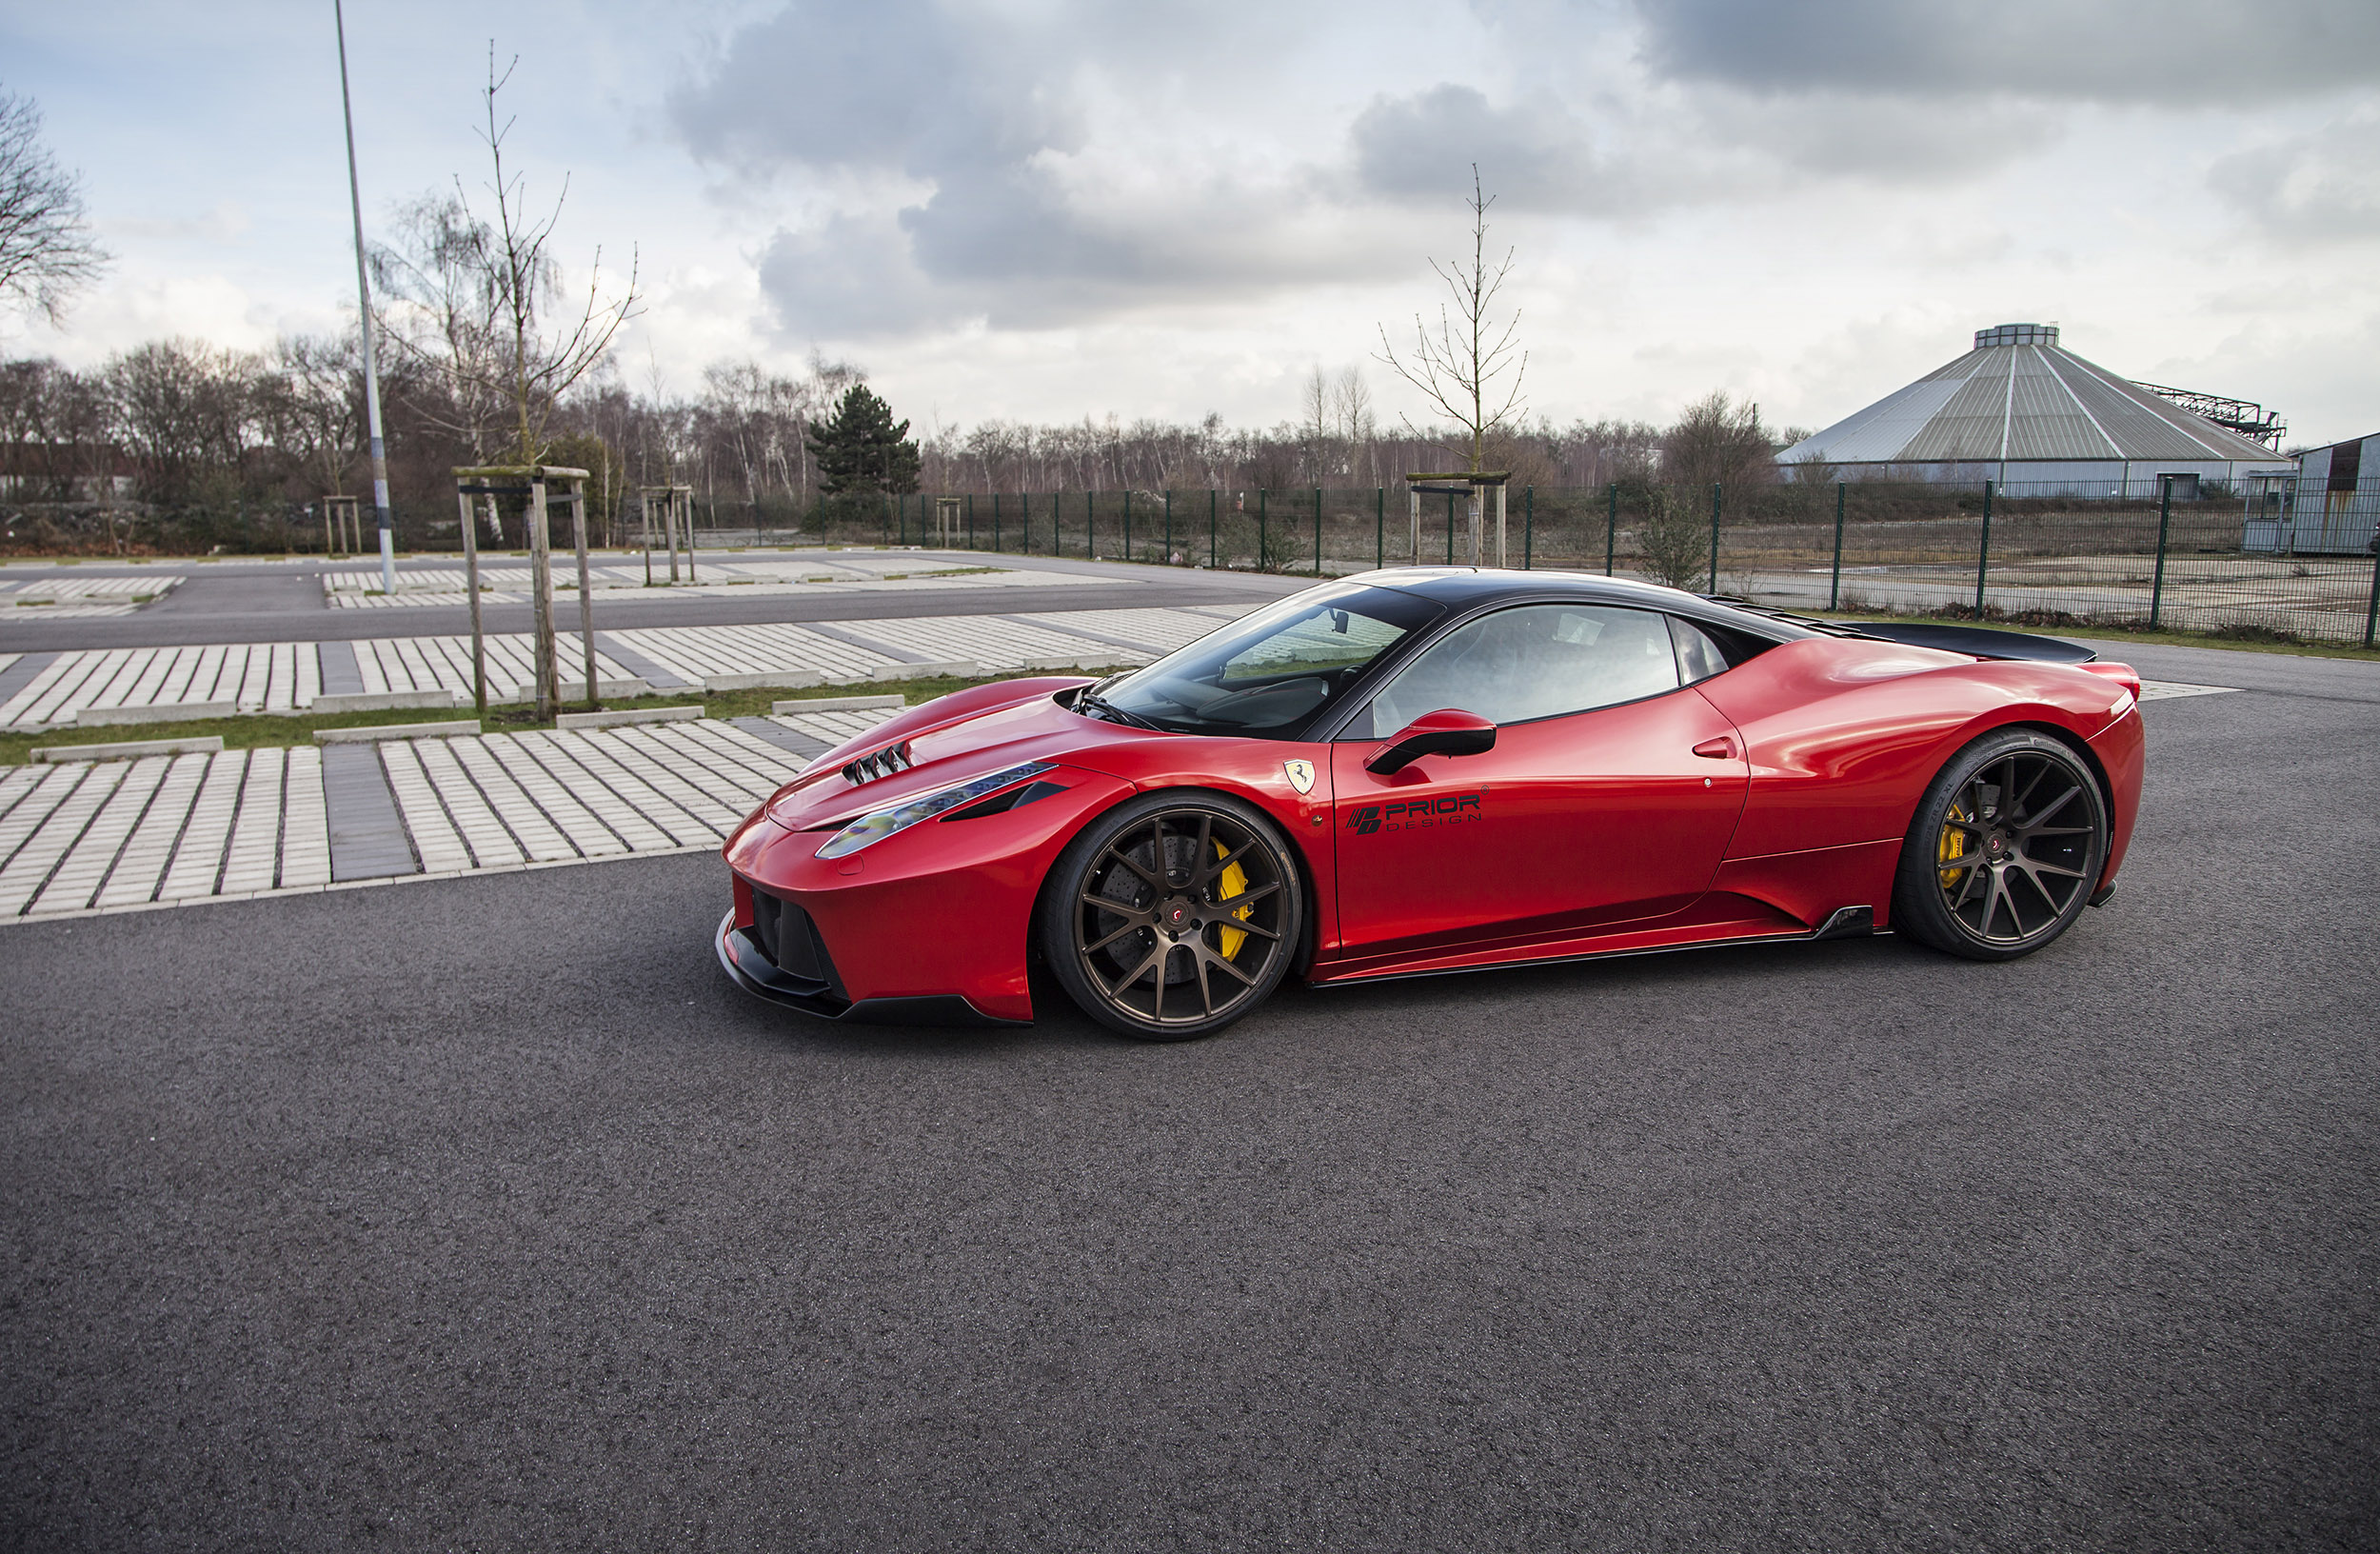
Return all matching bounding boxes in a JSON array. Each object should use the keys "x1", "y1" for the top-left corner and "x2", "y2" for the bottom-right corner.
[{"x1": 0, "y1": 0, "x2": 2380, "y2": 443}]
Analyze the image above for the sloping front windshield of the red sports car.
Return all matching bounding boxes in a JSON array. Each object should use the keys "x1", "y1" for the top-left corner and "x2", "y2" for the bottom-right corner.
[{"x1": 1100, "y1": 583, "x2": 1440, "y2": 740}]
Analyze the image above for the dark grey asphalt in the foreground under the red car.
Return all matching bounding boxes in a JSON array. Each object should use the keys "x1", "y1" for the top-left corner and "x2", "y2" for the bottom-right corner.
[{"x1": 0, "y1": 649, "x2": 2380, "y2": 1552}]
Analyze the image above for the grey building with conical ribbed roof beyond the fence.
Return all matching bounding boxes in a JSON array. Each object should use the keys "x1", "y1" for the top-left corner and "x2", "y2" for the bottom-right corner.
[{"x1": 1778, "y1": 324, "x2": 2292, "y2": 497}]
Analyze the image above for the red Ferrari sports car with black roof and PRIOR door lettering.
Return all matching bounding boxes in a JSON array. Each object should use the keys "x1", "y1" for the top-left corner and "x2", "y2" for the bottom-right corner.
[{"x1": 719, "y1": 567, "x2": 2142, "y2": 1040}]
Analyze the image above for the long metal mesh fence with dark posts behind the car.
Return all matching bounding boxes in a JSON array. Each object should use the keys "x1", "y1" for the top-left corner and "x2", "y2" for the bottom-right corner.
[{"x1": 790, "y1": 481, "x2": 2380, "y2": 645}]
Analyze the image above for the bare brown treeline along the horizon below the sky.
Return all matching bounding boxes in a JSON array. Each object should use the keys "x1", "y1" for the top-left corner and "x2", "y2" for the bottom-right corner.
[{"x1": 0, "y1": 335, "x2": 1797, "y2": 552}]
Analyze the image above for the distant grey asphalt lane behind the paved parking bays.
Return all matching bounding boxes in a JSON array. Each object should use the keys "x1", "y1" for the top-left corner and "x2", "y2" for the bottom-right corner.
[{"x1": 0, "y1": 552, "x2": 1312, "y2": 652}]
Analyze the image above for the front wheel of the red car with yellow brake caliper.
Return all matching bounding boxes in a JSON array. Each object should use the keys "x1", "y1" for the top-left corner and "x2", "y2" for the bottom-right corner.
[{"x1": 1041, "y1": 790, "x2": 1304, "y2": 1043}]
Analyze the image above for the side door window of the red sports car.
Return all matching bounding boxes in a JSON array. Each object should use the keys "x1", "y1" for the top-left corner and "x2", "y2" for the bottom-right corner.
[{"x1": 1345, "y1": 605, "x2": 1685, "y2": 740}]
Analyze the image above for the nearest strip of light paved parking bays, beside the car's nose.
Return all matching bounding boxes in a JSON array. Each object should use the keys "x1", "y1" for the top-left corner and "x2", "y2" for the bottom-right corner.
[{"x1": 0, "y1": 709, "x2": 893, "y2": 924}]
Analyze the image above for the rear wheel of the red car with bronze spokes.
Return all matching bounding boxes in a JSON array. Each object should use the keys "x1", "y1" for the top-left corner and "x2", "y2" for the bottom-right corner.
[{"x1": 1893, "y1": 728, "x2": 2109, "y2": 962}]
